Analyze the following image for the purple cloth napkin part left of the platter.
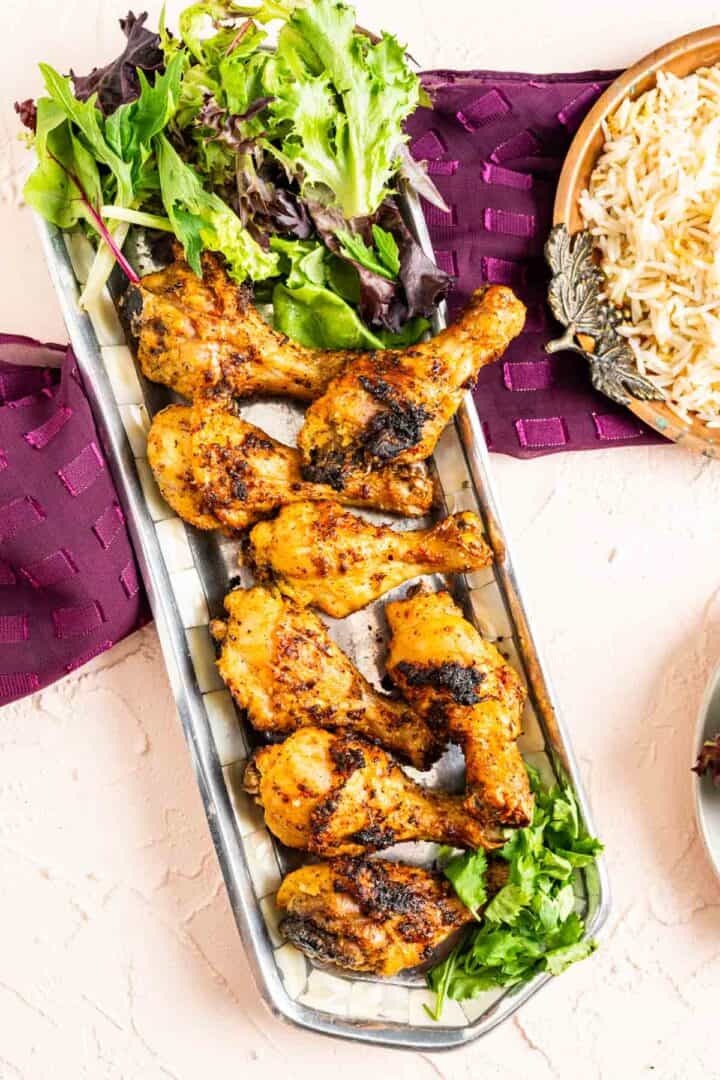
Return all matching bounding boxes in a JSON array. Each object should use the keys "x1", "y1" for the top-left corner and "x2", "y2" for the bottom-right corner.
[{"x1": 0, "y1": 334, "x2": 148, "y2": 705}]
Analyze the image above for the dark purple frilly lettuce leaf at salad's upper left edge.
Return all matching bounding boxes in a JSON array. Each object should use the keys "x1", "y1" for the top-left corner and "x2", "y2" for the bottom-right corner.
[{"x1": 70, "y1": 11, "x2": 165, "y2": 117}]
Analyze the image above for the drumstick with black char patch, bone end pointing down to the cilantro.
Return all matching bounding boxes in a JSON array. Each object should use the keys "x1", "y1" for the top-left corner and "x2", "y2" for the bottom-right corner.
[{"x1": 385, "y1": 592, "x2": 533, "y2": 826}]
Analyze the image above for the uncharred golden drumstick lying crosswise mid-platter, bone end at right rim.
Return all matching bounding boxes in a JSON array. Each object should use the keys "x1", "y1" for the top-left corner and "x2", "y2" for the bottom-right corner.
[{"x1": 250, "y1": 502, "x2": 492, "y2": 619}]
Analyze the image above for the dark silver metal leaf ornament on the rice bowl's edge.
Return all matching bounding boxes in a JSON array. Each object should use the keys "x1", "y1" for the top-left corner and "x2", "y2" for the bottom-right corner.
[{"x1": 545, "y1": 225, "x2": 664, "y2": 405}]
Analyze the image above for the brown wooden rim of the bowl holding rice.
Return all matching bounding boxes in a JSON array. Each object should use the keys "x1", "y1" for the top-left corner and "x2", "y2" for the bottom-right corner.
[{"x1": 553, "y1": 26, "x2": 720, "y2": 458}]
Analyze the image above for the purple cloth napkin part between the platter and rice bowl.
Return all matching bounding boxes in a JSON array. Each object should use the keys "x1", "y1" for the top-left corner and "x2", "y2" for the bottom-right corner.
[{"x1": 409, "y1": 71, "x2": 663, "y2": 458}]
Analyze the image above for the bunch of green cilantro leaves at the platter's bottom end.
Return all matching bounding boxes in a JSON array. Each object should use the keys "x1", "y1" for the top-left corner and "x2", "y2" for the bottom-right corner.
[{"x1": 427, "y1": 766, "x2": 602, "y2": 1020}]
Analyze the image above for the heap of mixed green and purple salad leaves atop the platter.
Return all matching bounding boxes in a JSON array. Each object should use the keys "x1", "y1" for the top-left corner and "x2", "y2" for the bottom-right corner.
[{"x1": 16, "y1": 0, "x2": 450, "y2": 348}]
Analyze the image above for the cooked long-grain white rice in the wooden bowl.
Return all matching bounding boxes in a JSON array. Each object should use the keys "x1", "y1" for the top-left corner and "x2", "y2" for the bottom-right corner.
[{"x1": 581, "y1": 67, "x2": 720, "y2": 428}]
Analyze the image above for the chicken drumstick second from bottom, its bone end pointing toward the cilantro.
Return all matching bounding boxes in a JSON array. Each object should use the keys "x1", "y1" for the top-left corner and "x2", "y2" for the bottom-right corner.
[{"x1": 245, "y1": 728, "x2": 503, "y2": 858}]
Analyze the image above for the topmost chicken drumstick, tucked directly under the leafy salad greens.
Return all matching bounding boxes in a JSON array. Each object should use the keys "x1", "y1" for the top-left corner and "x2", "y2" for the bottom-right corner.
[{"x1": 123, "y1": 254, "x2": 353, "y2": 401}]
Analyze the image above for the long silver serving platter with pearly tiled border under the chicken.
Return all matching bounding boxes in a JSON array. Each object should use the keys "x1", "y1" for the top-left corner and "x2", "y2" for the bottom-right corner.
[{"x1": 39, "y1": 195, "x2": 610, "y2": 1051}]
